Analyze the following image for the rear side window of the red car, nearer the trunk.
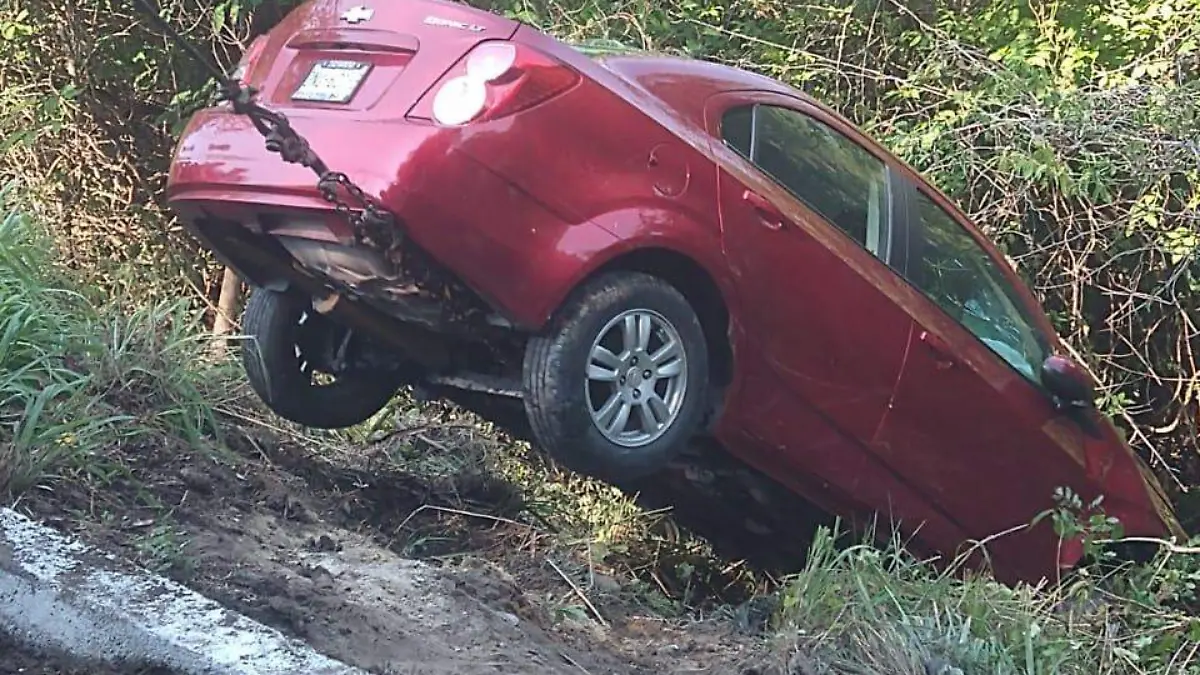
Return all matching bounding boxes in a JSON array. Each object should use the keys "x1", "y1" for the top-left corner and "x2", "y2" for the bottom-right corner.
[{"x1": 721, "y1": 104, "x2": 889, "y2": 257}]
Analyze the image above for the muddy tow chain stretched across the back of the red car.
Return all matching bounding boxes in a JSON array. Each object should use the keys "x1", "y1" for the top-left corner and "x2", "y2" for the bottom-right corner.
[{"x1": 134, "y1": 0, "x2": 402, "y2": 255}]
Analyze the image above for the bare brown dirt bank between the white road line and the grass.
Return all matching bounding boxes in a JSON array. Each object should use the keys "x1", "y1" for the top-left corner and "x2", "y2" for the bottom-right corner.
[{"x1": 11, "y1": 401, "x2": 777, "y2": 675}]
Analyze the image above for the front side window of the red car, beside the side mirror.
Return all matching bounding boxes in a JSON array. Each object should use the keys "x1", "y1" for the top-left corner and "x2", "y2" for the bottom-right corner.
[{"x1": 906, "y1": 186, "x2": 1049, "y2": 382}]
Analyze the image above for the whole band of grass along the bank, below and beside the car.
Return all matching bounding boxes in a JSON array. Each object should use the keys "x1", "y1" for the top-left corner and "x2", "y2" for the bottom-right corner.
[{"x1": 0, "y1": 187, "x2": 1200, "y2": 675}]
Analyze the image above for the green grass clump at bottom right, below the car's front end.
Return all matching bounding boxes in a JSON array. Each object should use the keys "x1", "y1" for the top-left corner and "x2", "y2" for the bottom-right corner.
[{"x1": 776, "y1": 531, "x2": 1200, "y2": 675}]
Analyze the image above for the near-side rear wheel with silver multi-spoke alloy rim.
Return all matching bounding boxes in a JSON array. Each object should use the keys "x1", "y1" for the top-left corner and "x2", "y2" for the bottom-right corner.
[{"x1": 523, "y1": 271, "x2": 709, "y2": 483}]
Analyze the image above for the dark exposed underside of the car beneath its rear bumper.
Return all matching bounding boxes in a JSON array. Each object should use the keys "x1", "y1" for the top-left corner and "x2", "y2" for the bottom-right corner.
[{"x1": 193, "y1": 219, "x2": 524, "y2": 398}]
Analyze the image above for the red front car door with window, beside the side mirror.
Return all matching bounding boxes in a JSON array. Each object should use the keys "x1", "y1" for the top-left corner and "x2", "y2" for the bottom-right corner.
[{"x1": 875, "y1": 179, "x2": 1092, "y2": 575}]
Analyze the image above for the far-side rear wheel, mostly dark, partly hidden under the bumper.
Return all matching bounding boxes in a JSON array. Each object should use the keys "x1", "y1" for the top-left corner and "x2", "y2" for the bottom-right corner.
[{"x1": 241, "y1": 288, "x2": 397, "y2": 429}]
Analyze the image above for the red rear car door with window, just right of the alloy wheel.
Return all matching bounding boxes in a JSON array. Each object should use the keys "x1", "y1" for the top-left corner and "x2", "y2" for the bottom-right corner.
[{"x1": 706, "y1": 92, "x2": 958, "y2": 547}]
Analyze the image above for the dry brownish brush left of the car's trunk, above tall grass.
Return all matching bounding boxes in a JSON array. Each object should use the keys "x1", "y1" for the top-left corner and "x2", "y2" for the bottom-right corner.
[{"x1": 0, "y1": 0, "x2": 300, "y2": 299}]
